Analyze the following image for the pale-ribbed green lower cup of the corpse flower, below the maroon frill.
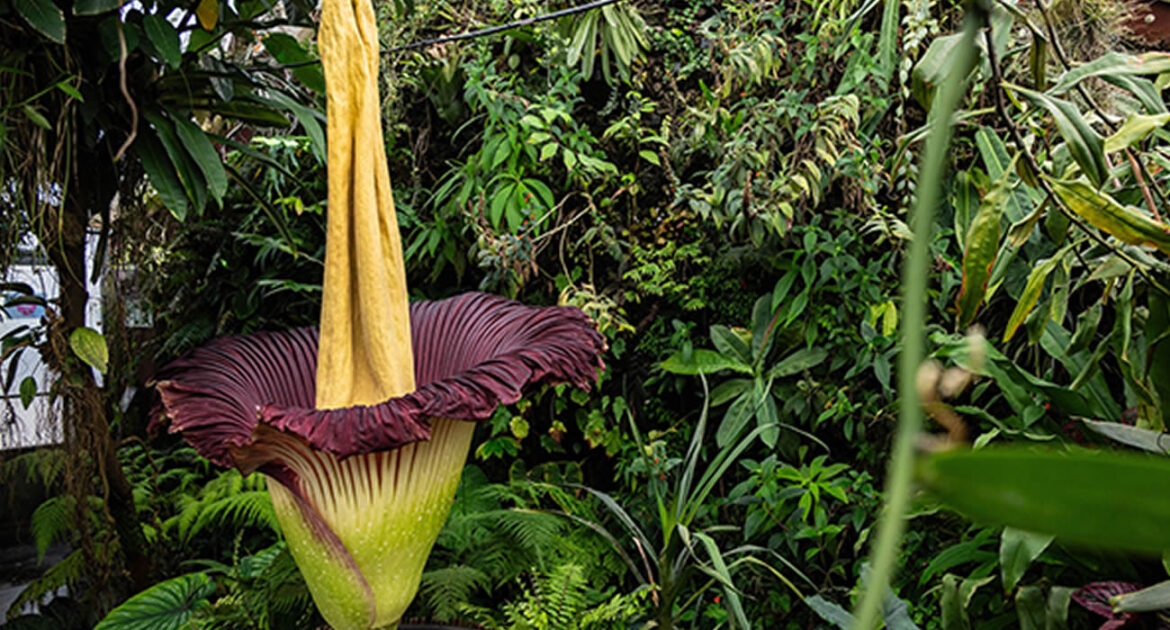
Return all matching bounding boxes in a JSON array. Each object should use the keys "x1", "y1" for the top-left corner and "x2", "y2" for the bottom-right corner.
[{"x1": 268, "y1": 419, "x2": 475, "y2": 630}]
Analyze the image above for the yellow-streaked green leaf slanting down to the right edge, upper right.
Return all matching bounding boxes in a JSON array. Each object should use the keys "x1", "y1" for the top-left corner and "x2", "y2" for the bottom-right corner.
[{"x1": 1049, "y1": 179, "x2": 1170, "y2": 255}]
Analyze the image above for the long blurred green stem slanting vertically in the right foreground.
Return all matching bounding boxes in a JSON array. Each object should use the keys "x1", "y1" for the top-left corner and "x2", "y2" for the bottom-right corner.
[{"x1": 854, "y1": 6, "x2": 985, "y2": 630}]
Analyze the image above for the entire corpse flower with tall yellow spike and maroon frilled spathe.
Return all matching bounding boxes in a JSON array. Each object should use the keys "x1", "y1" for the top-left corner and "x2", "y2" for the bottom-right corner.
[{"x1": 149, "y1": 0, "x2": 604, "y2": 629}]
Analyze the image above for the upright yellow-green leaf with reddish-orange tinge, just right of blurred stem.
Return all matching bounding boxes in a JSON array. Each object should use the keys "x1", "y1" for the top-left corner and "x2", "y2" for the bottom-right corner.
[{"x1": 955, "y1": 159, "x2": 1012, "y2": 328}]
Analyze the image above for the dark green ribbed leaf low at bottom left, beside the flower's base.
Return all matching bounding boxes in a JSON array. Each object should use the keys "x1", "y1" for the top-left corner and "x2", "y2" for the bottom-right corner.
[{"x1": 95, "y1": 573, "x2": 215, "y2": 630}]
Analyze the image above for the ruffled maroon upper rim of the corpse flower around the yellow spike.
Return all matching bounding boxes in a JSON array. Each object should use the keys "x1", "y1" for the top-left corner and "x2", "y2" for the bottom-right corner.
[{"x1": 156, "y1": 293, "x2": 605, "y2": 472}]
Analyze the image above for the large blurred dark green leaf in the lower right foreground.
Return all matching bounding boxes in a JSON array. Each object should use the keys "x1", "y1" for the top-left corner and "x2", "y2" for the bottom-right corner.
[{"x1": 918, "y1": 447, "x2": 1170, "y2": 554}]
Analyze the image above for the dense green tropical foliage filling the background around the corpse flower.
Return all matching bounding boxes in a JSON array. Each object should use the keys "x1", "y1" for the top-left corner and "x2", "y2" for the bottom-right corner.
[{"x1": 0, "y1": 0, "x2": 1170, "y2": 630}]
